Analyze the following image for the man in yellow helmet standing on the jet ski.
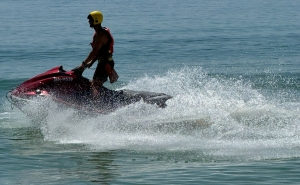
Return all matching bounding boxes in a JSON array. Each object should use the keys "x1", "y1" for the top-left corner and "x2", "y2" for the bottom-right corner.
[{"x1": 79, "y1": 11, "x2": 119, "y2": 98}]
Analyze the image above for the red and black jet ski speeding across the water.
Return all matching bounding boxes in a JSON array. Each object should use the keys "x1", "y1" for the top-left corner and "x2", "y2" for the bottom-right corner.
[{"x1": 7, "y1": 66, "x2": 172, "y2": 117}]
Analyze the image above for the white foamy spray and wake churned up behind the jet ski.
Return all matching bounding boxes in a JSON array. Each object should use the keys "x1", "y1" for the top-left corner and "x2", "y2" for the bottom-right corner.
[{"x1": 4, "y1": 67, "x2": 300, "y2": 160}]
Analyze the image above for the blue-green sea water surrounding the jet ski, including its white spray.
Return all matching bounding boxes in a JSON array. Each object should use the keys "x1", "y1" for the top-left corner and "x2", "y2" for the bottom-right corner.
[{"x1": 0, "y1": 0, "x2": 300, "y2": 185}]
